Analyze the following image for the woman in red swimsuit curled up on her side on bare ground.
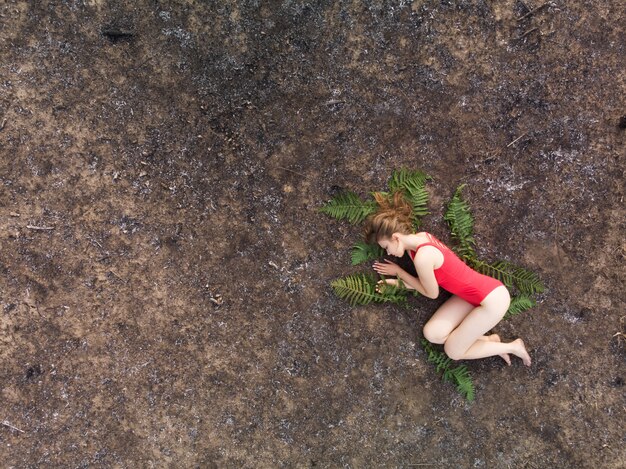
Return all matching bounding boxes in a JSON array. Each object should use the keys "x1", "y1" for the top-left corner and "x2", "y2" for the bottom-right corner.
[{"x1": 366, "y1": 192, "x2": 530, "y2": 366}]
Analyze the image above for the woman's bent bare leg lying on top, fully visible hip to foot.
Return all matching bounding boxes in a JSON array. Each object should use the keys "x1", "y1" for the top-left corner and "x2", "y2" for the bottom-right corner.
[{"x1": 444, "y1": 287, "x2": 530, "y2": 366}]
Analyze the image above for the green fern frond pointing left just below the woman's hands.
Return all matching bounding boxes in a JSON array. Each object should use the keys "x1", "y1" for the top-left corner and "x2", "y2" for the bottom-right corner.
[{"x1": 330, "y1": 273, "x2": 408, "y2": 306}]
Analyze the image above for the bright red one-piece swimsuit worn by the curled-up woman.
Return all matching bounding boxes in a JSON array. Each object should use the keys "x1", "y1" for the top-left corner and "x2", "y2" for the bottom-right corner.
[{"x1": 409, "y1": 233, "x2": 502, "y2": 306}]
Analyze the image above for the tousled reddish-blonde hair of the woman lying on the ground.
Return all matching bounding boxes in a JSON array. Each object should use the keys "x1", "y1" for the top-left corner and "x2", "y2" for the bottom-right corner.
[{"x1": 365, "y1": 191, "x2": 413, "y2": 244}]
